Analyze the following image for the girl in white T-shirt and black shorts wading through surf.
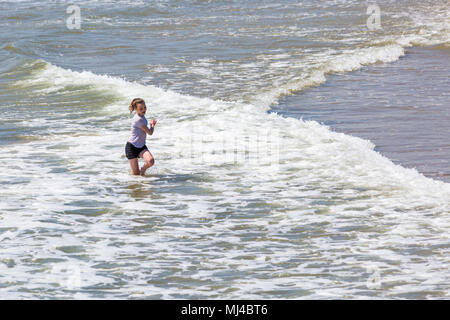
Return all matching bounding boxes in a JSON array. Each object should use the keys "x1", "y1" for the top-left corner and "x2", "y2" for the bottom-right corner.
[{"x1": 125, "y1": 98, "x2": 156, "y2": 176}]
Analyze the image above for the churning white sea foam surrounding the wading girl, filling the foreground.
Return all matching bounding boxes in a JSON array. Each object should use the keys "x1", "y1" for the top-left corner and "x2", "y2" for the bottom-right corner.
[{"x1": 0, "y1": 56, "x2": 450, "y2": 298}]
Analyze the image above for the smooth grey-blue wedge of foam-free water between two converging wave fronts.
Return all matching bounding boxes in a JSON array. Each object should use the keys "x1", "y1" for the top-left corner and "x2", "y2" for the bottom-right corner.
[{"x1": 269, "y1": 45, "x2": 450, "y2": 183}]
